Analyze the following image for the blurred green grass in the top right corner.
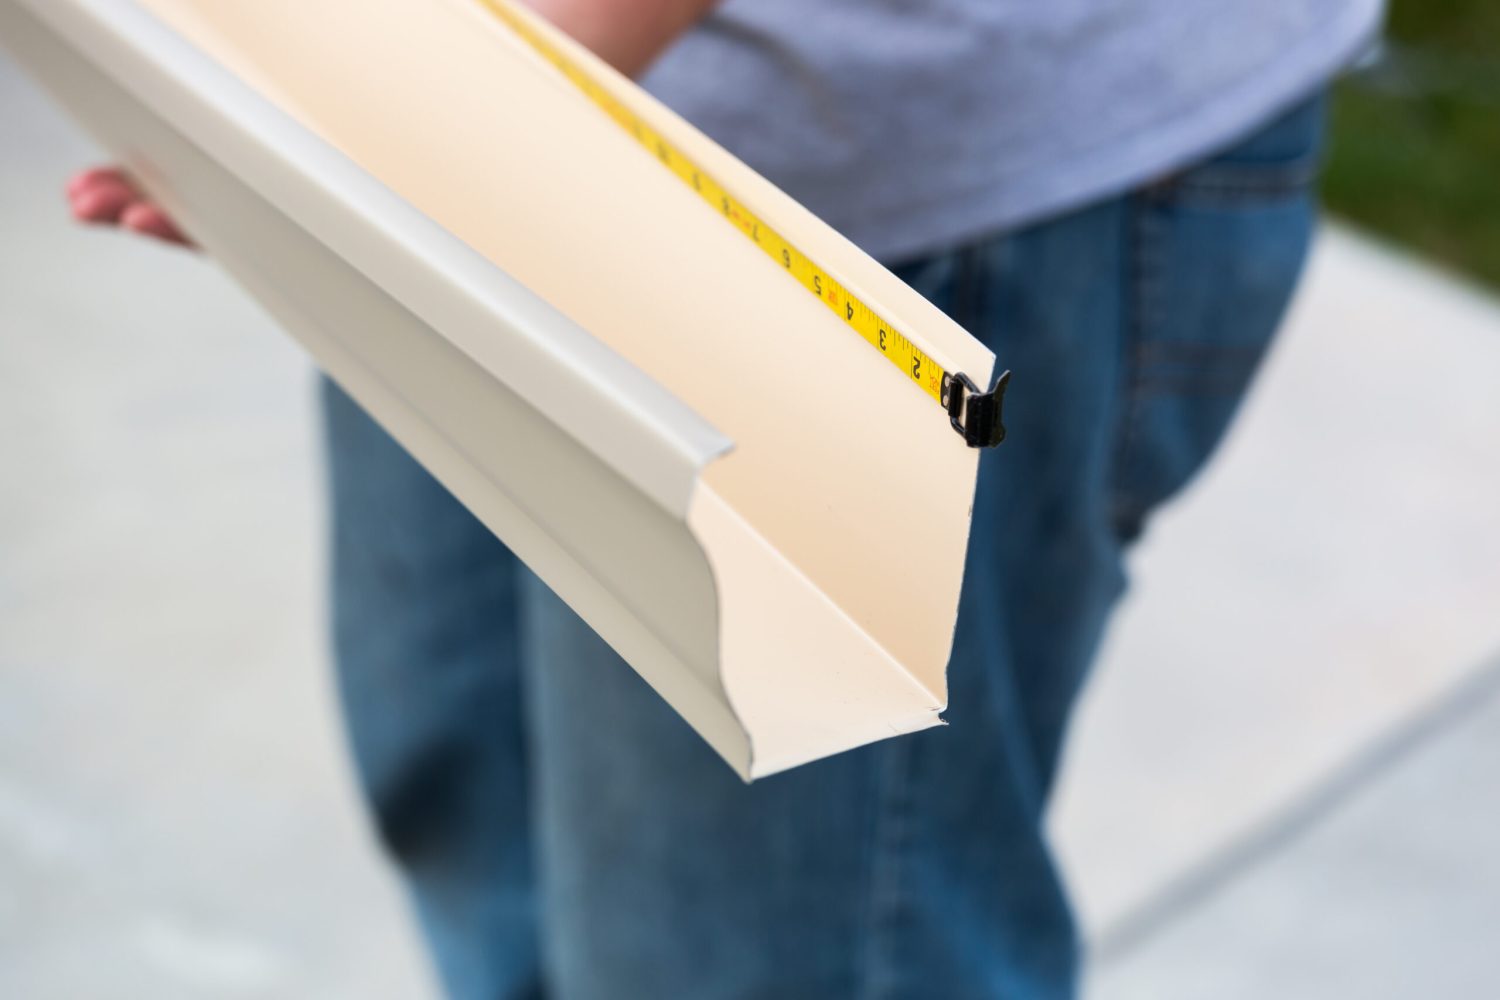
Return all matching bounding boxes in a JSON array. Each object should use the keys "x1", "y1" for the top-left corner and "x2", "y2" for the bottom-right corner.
[{"x1": 1325, "y1": 0, "x2": 1500, "y2": 285}]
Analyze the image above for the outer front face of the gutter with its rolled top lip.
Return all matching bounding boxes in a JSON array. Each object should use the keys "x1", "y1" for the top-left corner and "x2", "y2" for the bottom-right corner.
[{"x1": 0, "y1": 0, "x2": 762, "y2": 774}]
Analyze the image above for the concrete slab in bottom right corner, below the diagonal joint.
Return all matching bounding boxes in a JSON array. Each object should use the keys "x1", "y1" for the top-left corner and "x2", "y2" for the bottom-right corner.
[{"x1": 1094, "y1": 661, "x2": 1500, "y2": 1000}]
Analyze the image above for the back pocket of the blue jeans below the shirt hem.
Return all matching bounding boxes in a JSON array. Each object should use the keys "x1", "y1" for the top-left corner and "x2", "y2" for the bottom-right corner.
[{"x1": 1113, "y1": 99, "x2": 1323, "y2": 541}]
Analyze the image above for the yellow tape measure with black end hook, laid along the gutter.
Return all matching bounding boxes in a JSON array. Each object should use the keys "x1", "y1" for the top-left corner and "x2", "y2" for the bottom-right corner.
[{"x1": 479, "y1": 0, "x2": 1010, "y2": 447}]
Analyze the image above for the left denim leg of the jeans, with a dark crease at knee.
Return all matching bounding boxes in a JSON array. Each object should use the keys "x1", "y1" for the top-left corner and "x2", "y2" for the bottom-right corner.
[{"x1": 323, "y1": 381, "x2": 542, "y2": 1000}]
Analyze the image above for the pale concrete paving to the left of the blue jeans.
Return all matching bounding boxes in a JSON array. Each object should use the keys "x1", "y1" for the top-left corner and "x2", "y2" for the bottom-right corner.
[{"x1": 0, "y1": 58, "x2": 429, "y2": 1000}]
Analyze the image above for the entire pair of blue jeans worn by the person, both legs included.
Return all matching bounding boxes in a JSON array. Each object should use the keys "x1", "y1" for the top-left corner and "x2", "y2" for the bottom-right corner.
[{"x1": 326, "y1": 100, "x2": 1322, "y2": 1000}]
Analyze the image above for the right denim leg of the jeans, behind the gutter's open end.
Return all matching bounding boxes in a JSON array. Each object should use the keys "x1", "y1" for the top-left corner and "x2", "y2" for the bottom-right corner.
[{"x1": 525, "y1": 95, "x2": 1322, "y2": 1000}]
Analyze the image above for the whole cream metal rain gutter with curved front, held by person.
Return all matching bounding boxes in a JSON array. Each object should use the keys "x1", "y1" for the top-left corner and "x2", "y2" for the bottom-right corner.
[{"x1": 0, "y1": 0, "x2": 993, "y2": 778}]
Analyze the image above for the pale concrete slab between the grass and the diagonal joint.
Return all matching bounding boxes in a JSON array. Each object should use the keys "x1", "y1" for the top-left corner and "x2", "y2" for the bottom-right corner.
[{"x1": 1053, "y1": 228, "x2": 1500, "y2": 934}]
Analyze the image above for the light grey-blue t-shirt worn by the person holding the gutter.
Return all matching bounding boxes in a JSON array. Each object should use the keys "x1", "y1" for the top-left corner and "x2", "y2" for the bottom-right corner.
[{"x1": 644, "y1": 0, "x2": 1383, "y2": 261}]
